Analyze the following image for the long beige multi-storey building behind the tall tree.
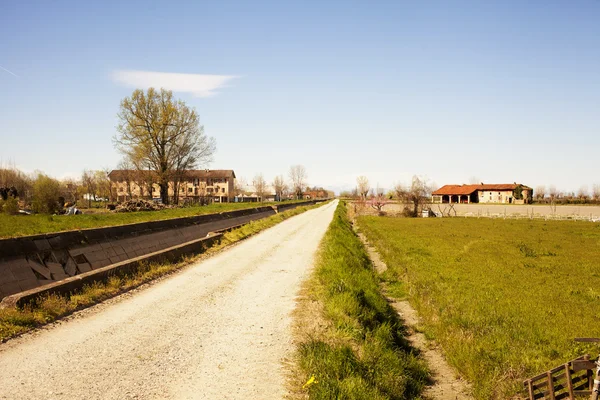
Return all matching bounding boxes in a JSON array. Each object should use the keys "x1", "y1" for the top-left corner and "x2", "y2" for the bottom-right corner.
[{"x1": 108, "y1": 169, "x2": 235, "y2": 203}]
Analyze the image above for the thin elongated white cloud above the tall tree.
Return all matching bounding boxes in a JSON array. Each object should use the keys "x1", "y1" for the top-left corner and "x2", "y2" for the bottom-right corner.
[{"x1": 112, "y1": 70, "x2": 237, "y2": 97}]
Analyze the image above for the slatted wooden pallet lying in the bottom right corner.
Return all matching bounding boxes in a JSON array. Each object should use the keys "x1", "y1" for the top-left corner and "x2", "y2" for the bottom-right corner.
[{"x1": 523, "y1": 354, "x2": 596, "y2": 400}]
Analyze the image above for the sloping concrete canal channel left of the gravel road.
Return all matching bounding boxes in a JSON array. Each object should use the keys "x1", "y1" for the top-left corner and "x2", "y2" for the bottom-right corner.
[{"x1": 0, "y1": 201, "x2": 316, "y2": 299}]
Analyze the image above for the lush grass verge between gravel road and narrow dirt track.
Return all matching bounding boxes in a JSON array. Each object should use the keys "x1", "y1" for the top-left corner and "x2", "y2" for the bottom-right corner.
[{"x1": 295, "y1": 202, "x2": 428, "y2": 400}]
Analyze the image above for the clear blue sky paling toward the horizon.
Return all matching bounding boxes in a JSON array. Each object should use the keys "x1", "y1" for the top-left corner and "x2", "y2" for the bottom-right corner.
[{"x1": 0, "y1": 0, "x2": 600, "y2": 191}]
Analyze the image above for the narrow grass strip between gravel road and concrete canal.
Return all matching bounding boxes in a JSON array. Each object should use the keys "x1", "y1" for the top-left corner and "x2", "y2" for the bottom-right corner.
[{"x1": 0, "y1": 203, "x2": 324, "y2": 341}]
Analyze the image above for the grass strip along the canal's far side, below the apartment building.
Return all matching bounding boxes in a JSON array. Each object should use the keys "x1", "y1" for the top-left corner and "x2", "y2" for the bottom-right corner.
[{"x1": 0, "y1": 202, "x2": 308, "y2": 238}]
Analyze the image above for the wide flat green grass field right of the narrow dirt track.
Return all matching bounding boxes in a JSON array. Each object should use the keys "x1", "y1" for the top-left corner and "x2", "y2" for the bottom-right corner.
[{"x1": 358, "y1": 217, "x2": 600, "y2": 399}]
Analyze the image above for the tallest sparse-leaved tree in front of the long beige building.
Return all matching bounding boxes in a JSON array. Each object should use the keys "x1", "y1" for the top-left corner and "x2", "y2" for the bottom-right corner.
[{"x1": 114, "y1": 88, "x2": 216, "y2": 204}]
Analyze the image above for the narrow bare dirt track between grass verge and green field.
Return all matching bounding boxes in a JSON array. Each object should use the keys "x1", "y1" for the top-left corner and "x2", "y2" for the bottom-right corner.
[{"x1": 358, "y1": 233, "x2": 473, "y2": 400}]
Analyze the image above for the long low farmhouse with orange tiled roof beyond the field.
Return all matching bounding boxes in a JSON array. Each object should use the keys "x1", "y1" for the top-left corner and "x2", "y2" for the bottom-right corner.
[{"x1": 431, "y1": 182, "x2": 533, "y2": 204}]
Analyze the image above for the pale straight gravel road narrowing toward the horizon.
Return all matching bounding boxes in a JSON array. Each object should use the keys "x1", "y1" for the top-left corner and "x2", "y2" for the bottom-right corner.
[{"x1": 0, "y1": 201, "x2": 337, "y2": 399}]
